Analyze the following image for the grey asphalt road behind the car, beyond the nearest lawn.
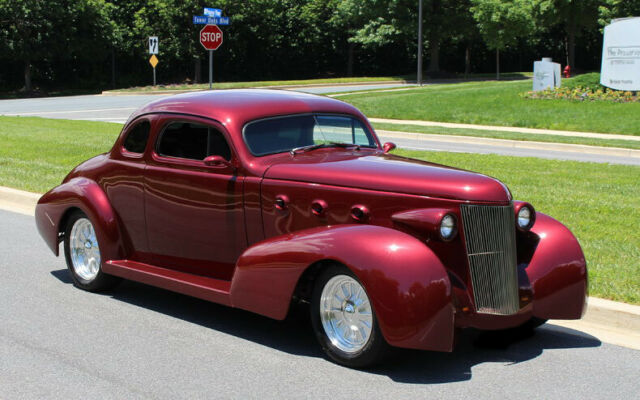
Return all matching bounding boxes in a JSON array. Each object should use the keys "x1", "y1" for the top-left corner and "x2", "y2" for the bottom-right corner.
[{"x1": 0, "y1": 84, "x2": 640, "y2": 165}]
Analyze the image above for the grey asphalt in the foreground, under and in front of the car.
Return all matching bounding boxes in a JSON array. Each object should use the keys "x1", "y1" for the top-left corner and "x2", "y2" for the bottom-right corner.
[{"x1": 0, "y1": 210, "x2": 640, "y2": 400}]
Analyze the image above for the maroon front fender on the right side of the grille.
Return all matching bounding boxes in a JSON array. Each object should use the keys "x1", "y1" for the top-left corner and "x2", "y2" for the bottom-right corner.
[{"x1": 526, "y1": 213, "x2": 587, "y2": 319}]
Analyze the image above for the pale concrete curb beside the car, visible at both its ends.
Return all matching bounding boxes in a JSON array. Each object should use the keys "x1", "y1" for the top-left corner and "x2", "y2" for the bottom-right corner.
[{"x1": 0, "y1": 186, "x2": 640, "y2": 350}]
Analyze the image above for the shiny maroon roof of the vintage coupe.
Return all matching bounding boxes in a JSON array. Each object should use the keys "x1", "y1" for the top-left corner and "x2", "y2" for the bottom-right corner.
[{"x1": 129, "y1": 89, "x2": 364, "y2": 126}]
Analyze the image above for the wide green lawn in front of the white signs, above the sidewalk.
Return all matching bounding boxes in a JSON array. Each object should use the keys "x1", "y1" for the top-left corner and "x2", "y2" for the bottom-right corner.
[{"x1": 338, "y1": 81, "x2": 640, "y2": 135}]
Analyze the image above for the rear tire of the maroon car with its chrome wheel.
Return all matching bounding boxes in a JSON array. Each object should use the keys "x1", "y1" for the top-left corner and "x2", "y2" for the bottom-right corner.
[{"x1": 64, "y1": 210, "x2": 119, "y2": 292}]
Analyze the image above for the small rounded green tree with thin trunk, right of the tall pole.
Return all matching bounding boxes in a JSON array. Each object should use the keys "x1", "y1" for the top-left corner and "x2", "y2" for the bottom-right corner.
[{"x1": 471, "y1": 0, "x2": 534, "y2": 80}]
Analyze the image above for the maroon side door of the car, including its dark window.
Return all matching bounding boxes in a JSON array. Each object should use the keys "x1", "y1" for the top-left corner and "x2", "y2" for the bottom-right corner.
[{"x1": 145, "y1": 116, "x2": 247, "y2": 280}]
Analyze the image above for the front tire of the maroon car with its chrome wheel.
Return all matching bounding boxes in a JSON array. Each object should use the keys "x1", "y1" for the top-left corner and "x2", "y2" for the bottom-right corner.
[{"x1": 310, "y1": 265, "x2": 389, "y2": 368}]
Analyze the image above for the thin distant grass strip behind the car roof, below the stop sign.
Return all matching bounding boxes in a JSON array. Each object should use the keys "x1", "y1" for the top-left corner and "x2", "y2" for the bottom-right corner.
[{"x1": 112, "y1": 76, "x2": 407, "y2": 93}]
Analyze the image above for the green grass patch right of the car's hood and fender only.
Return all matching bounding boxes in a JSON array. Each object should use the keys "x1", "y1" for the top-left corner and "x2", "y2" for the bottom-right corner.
[{"x1": 394, "y1": 150, "x2": 640, "y2": 304}]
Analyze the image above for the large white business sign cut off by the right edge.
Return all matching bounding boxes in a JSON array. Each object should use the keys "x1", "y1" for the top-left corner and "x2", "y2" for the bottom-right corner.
[{"x1": 600, "y1": 17, "x2": 640, "y2": 91}]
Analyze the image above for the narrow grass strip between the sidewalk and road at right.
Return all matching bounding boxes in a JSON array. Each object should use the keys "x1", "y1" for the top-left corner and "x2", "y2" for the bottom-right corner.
[{"x1": 373, "y1": 123, "x2": 640, "y2": 149}]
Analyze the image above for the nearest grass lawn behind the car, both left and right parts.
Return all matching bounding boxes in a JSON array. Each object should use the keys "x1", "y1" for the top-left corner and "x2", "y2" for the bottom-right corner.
[{"x1": 0, "y1": 117, "x2": 640, "y2": 304}]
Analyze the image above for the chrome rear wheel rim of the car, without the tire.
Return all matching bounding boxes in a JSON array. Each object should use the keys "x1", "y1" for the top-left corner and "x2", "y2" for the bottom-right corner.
[{"x1": 69, "y1": 218, "x2": 101, "y2": 282}]
